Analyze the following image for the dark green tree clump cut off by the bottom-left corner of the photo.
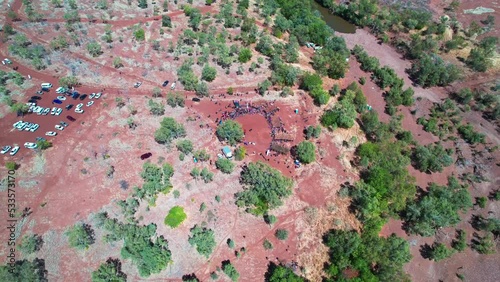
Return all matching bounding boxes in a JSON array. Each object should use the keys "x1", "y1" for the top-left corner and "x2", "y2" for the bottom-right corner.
[{"x1": 0, "y1": 258, "x2": 49, "y2": 282}]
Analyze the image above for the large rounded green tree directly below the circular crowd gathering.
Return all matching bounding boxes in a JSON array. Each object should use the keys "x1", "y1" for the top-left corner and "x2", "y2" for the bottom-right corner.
[{"x1": 235, "y1": 162, "x2": 293, "y2": 215}]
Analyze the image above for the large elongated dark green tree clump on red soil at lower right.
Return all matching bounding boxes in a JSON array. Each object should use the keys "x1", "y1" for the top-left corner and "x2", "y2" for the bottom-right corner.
[{"x1": 404, "y1": 177, "x2": 472, "y2": 236}]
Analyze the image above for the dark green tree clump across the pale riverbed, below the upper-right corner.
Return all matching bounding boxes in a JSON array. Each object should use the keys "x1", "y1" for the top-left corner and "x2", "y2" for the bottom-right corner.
[{"x1": 409, "y1": 54, "x2": 461, "y2": 87}]
